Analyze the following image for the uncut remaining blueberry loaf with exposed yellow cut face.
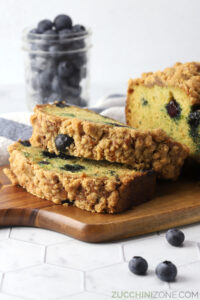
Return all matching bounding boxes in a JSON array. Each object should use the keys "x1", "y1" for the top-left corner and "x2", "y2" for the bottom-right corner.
[{"x1": 126, "y1": 62, "x2": 200, "y2": 162}]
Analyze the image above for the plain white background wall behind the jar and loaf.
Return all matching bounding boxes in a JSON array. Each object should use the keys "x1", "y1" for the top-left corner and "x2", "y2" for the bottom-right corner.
[{"x1": 0, "y1": 0, "x2": 200, "y2": 91}]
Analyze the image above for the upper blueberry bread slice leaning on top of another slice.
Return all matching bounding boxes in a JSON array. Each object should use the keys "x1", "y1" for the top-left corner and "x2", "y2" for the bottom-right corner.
[{"x1": 31, "y1": 102, "x2": 188, "y2": 179}]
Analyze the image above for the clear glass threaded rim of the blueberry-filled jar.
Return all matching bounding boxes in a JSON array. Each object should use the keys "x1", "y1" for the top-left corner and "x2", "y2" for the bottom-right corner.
[{"x1": 22, "y1": 27, "x2": 92, "y2": 55}]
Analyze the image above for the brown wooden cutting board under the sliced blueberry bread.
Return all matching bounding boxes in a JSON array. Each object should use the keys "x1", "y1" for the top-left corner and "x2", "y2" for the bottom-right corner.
[{"x1": 0, "y1": 167, "x2": 200, "y2": 242}]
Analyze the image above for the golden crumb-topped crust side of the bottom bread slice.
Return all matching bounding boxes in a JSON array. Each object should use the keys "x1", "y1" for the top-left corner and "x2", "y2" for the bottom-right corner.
[{"x1": 4, "y1": 143, "x2": 155, "y2": 213}]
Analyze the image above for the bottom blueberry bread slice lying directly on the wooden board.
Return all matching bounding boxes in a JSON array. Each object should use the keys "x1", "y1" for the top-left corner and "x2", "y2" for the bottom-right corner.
[{"x1": 4, "y1": 142, "x2": 156, "y2": 213}]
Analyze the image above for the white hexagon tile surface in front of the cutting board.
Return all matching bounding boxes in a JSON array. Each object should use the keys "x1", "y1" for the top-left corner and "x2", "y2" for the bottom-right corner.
[{"x1": 0, "y1": 224, "x2": 200, "y2": 300}]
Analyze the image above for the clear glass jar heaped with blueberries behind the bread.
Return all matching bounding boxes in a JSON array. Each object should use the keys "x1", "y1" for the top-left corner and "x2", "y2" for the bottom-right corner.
[{"x1": 23, "y1": 15, "x2": 91, "y2": 111}]
